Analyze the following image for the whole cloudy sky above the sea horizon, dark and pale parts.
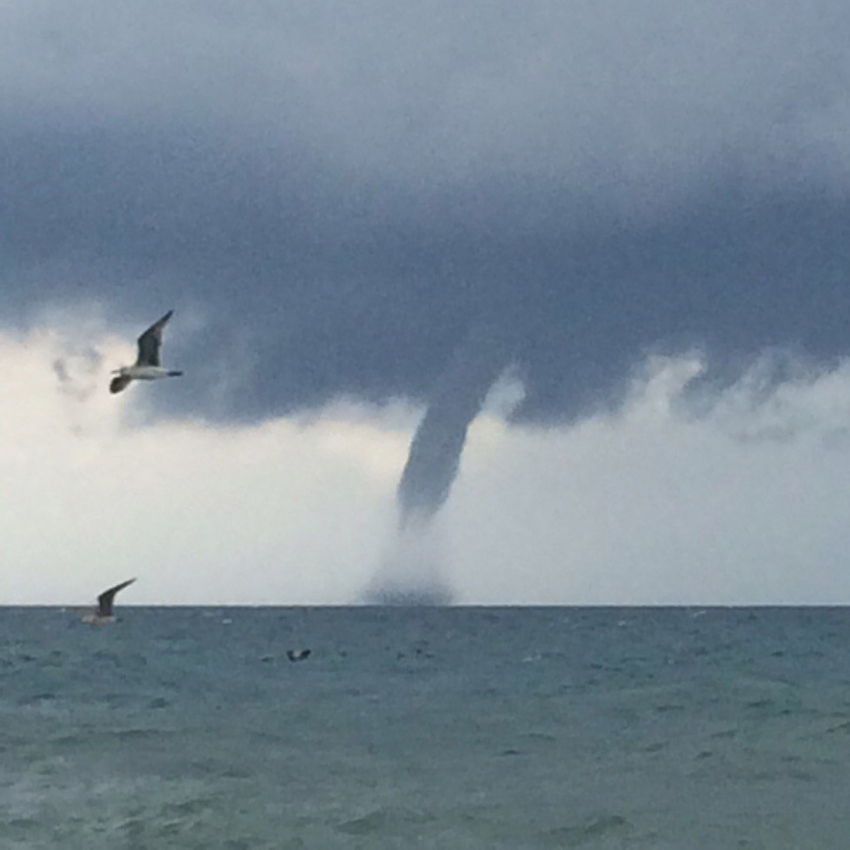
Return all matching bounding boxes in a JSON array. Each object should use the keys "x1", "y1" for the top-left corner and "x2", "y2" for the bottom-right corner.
[{"x1": 0, "y1": 0, "x2": 850, "y2": 605}]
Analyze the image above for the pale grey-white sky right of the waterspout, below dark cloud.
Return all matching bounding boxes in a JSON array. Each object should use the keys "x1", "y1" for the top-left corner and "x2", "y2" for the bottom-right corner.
[{"x1": 447, "y1": 357, "x2": 850, "y2": 604}]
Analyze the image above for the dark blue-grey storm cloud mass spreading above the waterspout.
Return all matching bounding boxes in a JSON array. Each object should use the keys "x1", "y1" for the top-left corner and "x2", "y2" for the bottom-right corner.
[{"x1": 0, "y1": 0, "x2": 850, "y2": 418}]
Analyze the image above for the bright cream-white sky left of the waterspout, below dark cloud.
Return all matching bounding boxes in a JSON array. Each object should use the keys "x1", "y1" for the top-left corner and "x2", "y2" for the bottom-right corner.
[{"x1": 0, "y1": 318, "x2": 405, "y2": 604}]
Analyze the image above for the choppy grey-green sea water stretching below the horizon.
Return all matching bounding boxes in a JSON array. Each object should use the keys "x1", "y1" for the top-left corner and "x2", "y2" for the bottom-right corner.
[{"x1": 0, "y1": 606, "x2": 850, "y2": 850}]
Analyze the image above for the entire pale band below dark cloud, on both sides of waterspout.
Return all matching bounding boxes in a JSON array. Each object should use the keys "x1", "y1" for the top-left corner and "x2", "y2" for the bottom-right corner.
[{"x1": 0, "y1": 322, "x2": 850, "y2": 604}]
